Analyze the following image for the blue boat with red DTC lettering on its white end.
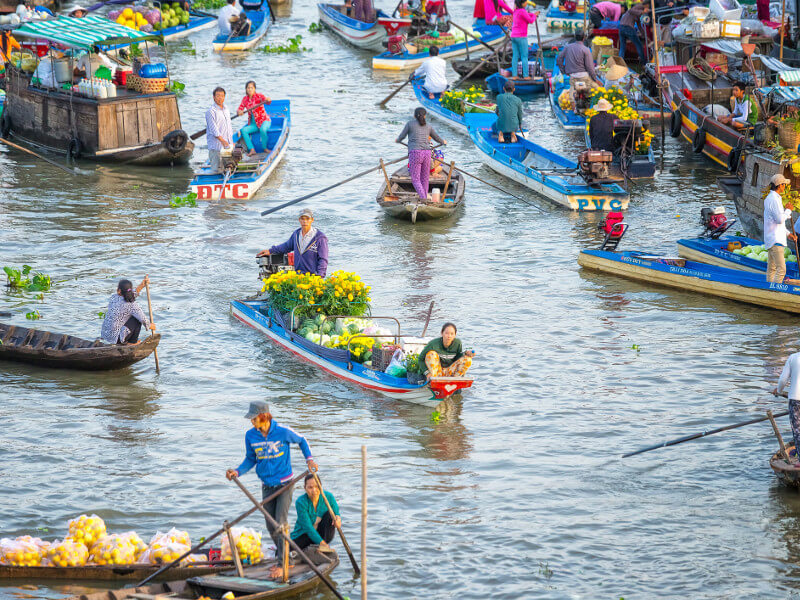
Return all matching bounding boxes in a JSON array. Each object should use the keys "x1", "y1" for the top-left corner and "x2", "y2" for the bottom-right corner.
[{"x1": 189, "y1": 100, "x2": 292, "y2": 200}]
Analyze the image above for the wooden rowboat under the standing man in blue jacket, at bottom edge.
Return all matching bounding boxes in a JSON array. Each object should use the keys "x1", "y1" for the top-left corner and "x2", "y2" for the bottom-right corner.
[{"x1": 61, "y1": 555, "x2": 339, "y2": 600}]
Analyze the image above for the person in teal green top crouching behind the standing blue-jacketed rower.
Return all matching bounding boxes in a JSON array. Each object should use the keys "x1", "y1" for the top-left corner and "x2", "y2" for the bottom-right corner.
[{"x1": 291, "y1": 474, "x2": 342, "y2": 552}]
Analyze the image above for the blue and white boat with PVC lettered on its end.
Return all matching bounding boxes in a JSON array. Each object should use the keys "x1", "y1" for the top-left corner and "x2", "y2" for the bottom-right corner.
[{"x1": 467, "y1": 115, "x2": 630, "y2": 211}]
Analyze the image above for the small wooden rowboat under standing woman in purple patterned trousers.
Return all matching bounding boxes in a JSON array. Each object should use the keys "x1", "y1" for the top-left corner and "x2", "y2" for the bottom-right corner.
[{"x1": 375, "y1": 165, "x2": 465, "y2": 223}]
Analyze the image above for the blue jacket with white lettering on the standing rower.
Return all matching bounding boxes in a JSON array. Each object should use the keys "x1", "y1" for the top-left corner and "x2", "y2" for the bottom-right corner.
[{"x1": 236, "y1": 420, "x2": 312, "y2": 486}]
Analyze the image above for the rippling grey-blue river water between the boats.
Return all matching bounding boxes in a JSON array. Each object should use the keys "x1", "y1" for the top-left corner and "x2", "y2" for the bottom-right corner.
[{"x1": 0, "y1": 3, "x2": 800, "y2": 599}]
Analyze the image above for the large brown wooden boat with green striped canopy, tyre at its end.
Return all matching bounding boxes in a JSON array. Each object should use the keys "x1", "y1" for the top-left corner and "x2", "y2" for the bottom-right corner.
[{"x1": 0, "y1": 15, "x2": 194, "y2": 165}]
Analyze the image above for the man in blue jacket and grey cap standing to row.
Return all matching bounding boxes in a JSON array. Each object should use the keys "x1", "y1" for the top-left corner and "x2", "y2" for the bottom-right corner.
[{"x1": 225, "y1": 401, "x2": 318, "y2": 577}]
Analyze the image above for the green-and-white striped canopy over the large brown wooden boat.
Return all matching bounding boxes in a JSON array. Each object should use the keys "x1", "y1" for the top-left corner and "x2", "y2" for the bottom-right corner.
[{"x1": 14, "y1": 15, "x2": 163, "y2": 50}]
